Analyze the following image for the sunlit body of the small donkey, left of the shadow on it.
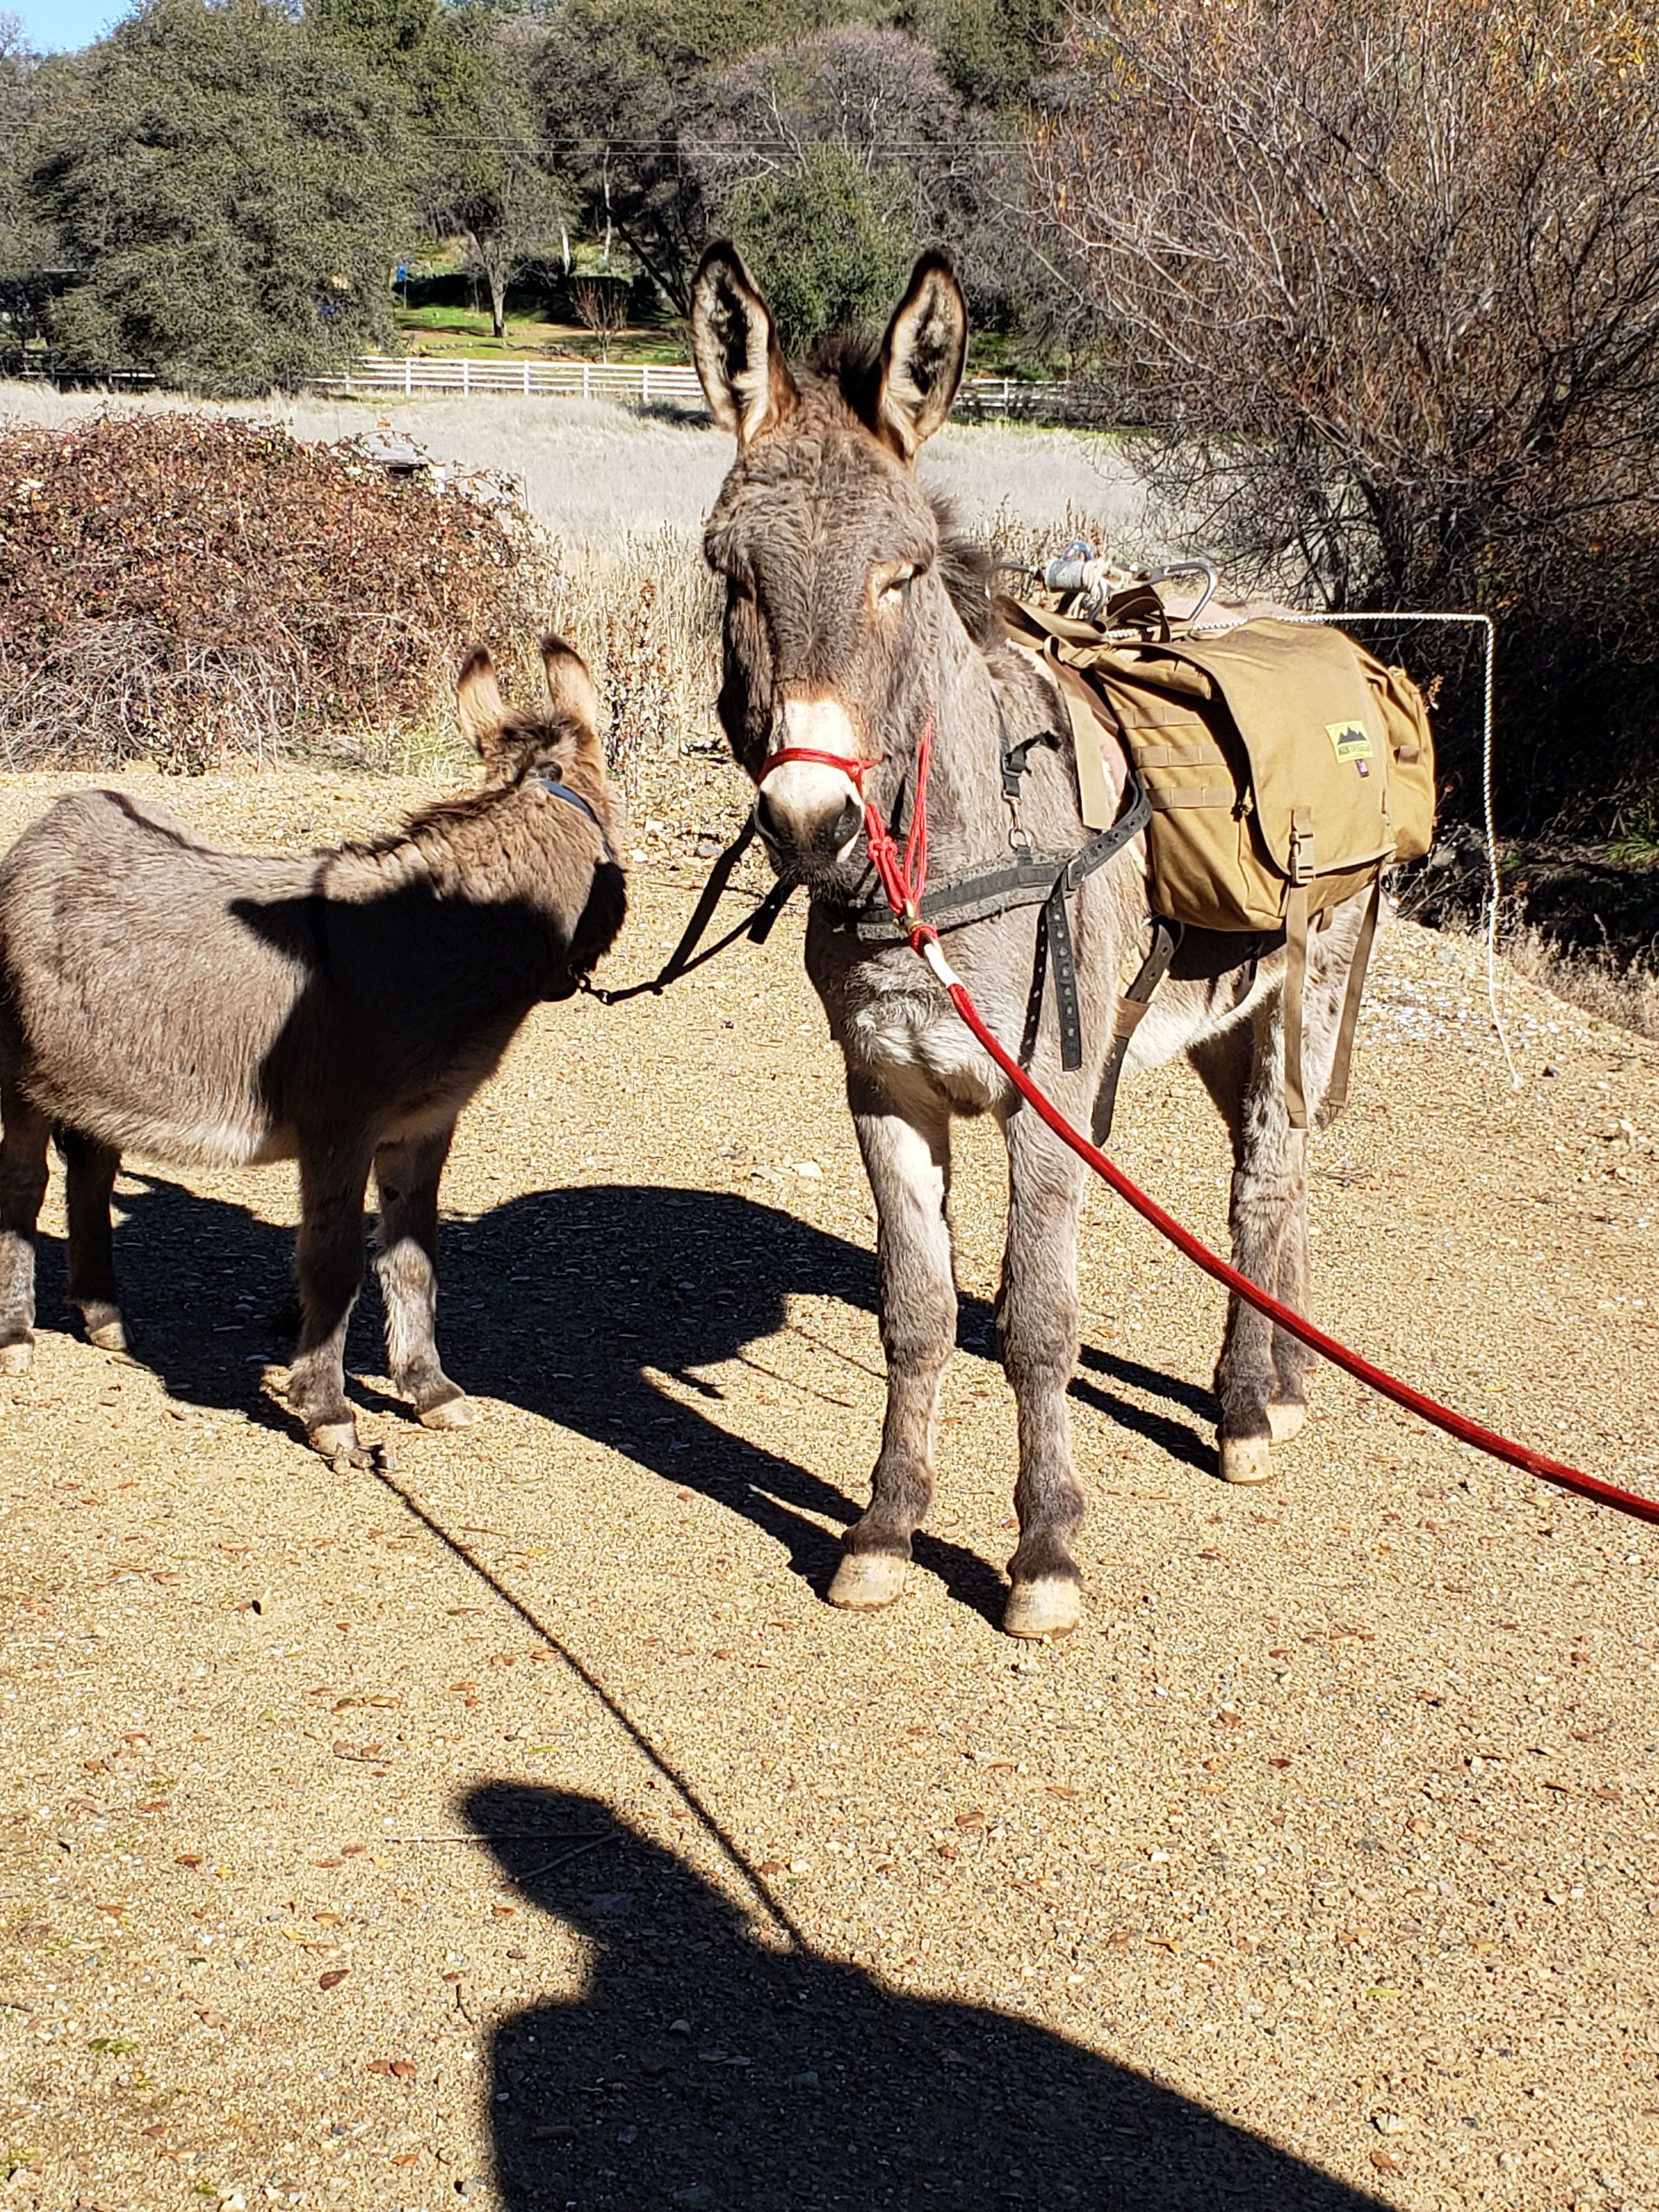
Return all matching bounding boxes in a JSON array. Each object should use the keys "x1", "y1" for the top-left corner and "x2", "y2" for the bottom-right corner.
[{"x1": 0, "y1": 792, "x2": 321, "y2": 1165}]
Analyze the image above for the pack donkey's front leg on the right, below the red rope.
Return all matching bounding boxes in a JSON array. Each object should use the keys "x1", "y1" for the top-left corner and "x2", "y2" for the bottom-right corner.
[{"x1": 997, "y1": 1108, "x2": 1086, "y2": 1637}]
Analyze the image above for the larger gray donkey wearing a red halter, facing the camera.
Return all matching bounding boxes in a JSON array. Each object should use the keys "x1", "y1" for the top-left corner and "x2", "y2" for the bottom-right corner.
[{"x1": 692, "y1": 246, "x2": 1365, "y2": 1637}]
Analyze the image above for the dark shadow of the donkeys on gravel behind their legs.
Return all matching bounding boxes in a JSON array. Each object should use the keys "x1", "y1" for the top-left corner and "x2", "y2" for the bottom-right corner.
[{"x1": 68, "y1": 1179, "x2": 1214, "y2": 1592}]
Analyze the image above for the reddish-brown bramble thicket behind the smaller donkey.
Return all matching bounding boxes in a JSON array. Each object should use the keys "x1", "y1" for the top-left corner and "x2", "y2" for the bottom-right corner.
[{"x1": 0, "y1": 413, "x2": 557, "y2": 770}]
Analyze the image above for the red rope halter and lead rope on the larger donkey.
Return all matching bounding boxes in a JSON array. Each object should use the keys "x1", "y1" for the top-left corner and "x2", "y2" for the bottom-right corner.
[{"x1": 758, "y1": 734, "x2": 1659, "y2": 1526}]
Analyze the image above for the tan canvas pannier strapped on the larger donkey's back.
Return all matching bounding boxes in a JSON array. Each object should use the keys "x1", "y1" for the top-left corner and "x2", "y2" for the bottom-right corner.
[{"x1": 1002, "y1": 602, "x2": 1433, "y2": 1126}]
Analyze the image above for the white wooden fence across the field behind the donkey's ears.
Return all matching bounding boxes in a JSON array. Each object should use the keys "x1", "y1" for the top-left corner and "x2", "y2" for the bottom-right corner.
[{"x1": 319, "y1": 354, "x2": 1095, "y2": 423}]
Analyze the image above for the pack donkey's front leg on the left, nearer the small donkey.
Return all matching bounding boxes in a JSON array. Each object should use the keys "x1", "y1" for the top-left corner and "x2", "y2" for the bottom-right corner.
[{"x1": 830, "y1": 1073, "x2": 956, "y2": 1608}]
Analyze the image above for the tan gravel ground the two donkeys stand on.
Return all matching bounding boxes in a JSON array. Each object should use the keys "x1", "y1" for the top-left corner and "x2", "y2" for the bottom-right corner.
[{"x1": 0, "y1": 774, "x2": 1659, "y2": 2212}]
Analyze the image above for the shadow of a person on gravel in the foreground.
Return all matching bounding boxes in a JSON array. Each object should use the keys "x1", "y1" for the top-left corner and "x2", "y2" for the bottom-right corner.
[{"x1": 465, "y1": 1783, "x2": 1378, "y2": 2212}]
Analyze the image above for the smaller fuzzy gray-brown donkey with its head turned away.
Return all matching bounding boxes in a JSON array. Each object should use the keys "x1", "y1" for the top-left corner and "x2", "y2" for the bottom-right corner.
[{"x1": 0, "y1": 637, "x2": 626, "y2": 1464}]
